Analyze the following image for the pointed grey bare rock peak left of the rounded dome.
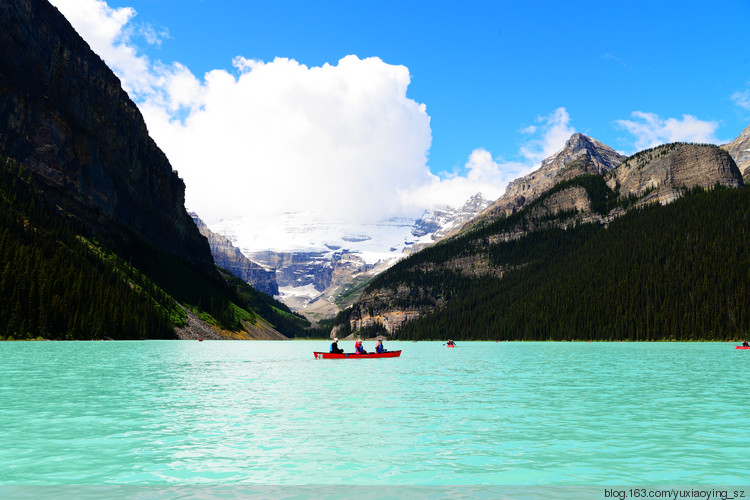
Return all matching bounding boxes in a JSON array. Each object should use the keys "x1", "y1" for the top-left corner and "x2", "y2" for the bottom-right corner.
[{"x1": 480, "y1": 134, "x2": 627, "y2": 220}]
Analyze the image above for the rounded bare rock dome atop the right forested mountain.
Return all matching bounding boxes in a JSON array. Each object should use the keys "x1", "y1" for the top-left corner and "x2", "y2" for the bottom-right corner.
[{"x1": 605, "y1": 143, "x2": 743, "y2": 204}]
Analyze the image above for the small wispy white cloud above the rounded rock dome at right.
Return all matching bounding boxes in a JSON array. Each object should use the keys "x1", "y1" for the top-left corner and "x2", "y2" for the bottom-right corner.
[{"x1": 615, "y1": 111, "x2": 719, "y2": 150}]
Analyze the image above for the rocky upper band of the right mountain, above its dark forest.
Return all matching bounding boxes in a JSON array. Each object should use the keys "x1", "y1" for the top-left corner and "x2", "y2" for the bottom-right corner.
[{"x1": 331, "y1": 136, "x2": 743, "y2": 337}]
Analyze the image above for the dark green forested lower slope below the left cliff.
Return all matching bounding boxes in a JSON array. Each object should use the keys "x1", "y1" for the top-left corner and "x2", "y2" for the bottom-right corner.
[{"x1": 0, "y1": 158, "x2": 309, "y2": 340}]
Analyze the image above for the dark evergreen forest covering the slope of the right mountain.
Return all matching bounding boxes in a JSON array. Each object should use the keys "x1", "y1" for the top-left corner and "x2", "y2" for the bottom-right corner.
[{"x1": 352, "y1": 176, "x2": 750, "y2": 340}]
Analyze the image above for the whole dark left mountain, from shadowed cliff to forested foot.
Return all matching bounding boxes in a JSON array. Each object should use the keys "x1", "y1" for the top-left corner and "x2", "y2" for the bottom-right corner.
[{"x1": 0, "y1": 0, "x2": 309, "y2": 339}]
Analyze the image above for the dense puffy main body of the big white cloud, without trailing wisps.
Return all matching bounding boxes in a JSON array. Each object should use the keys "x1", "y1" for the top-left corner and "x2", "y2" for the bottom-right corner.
[{"x1": 142, "y1": 56, "x2": 431, "y2": 220}]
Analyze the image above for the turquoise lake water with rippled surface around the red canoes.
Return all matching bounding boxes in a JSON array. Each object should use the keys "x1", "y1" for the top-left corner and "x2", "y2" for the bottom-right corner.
[{"x1": 0, "y1": 341, "x2": 750, "y2": 496}]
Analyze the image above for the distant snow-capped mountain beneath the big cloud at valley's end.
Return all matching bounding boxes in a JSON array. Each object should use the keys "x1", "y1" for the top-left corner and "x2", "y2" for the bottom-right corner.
[{"x1": 204, "y1": 193, "x2": 492, "y2": 319}]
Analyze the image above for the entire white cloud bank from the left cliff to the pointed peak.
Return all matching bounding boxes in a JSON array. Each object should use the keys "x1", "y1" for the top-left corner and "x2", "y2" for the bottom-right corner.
[{"x1": 48, "y1": 0, "x2": 573, "y2": 234}]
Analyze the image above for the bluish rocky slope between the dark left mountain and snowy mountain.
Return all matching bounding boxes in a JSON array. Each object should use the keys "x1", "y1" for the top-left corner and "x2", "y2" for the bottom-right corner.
[{"x1": 190, "y1": 214, "x2": 279, "y2": 296}]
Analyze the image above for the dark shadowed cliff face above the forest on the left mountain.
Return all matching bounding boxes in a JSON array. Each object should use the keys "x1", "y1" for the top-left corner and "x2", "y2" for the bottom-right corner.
[{"x1": 0, "y1": 0, "x2": 215, "y2": 272}]
